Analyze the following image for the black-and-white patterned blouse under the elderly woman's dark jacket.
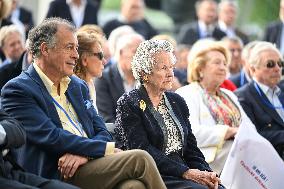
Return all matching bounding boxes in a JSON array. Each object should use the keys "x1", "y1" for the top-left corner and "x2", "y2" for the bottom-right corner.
[{"x1": 157, "y1": 97, "x2": 182, "y2": 155}]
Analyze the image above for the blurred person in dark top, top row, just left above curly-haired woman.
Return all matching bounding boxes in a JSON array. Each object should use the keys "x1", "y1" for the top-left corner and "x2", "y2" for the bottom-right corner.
[{"x1": 103, "y1": 0, "x2": 158, "y2": 39}]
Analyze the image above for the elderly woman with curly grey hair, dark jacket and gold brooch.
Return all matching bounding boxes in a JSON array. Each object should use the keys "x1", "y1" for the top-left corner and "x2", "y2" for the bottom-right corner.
[{"x1": 115, "y1": 39, "x2": 223, "y2": 189}]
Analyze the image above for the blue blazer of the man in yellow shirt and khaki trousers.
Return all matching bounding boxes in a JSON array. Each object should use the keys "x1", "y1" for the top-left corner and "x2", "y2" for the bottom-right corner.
[{"x1": 1, "y1": 66, "x2": 112, "y2": 179}]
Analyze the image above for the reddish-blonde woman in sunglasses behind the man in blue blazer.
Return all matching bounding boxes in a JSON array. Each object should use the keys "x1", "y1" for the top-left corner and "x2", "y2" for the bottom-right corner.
[{"x1": 74, "y1": 31, "x2": 106, "y2": 109}]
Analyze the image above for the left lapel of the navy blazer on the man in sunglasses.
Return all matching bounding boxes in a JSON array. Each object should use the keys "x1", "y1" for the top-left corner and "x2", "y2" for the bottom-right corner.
[{"x1": 249, "y1": 82, "x2": 283, "y2": 125}]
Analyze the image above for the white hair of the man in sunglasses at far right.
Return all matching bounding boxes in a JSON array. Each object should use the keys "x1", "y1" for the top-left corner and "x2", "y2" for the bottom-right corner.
[{"x1": 248, "y1": 41, "x2": 283, "y2": 67}]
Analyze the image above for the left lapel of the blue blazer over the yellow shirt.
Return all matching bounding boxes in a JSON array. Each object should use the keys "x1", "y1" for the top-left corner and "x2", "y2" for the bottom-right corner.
[{"x1": 24, "y1": 65, "x2": 62, "y2": 127}]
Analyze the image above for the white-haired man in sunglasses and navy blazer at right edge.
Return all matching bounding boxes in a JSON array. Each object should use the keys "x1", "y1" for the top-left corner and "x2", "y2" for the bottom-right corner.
[{"x1": 236, "y1": 42, "x2": 284, "y2": 160}]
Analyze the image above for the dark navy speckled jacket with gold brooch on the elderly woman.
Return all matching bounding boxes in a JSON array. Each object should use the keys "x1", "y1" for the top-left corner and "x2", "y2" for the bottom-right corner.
[{"x1": 115, "y1": 87, "x2": 211, "y2": 178}]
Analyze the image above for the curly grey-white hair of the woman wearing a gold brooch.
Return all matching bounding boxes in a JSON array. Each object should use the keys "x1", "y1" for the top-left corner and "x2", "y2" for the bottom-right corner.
[{"x1": 131, "y1": 39, "x2": 174, "y2": 82}]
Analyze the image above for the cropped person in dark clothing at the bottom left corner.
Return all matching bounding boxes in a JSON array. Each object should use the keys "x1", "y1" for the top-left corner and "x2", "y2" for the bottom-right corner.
[{"x1": 0, "y1": 110, "x2": 77, "y2": 189}]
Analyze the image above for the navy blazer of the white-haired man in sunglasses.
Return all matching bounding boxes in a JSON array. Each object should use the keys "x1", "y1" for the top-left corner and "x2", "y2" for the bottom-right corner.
[{"x1": 235, "y1": 81, "x2": 284, "y2": 158}]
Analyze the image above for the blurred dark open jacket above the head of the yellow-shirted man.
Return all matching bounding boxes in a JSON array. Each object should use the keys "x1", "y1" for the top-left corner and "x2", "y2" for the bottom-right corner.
[{"x1": 46, "y1": 0, "x2": 99, "y2": 25}]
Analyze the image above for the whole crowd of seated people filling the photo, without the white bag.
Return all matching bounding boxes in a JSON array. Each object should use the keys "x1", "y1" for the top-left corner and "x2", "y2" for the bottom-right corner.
[{"x1": 0, "y1": 0, "x2": 284, "y2": 189}]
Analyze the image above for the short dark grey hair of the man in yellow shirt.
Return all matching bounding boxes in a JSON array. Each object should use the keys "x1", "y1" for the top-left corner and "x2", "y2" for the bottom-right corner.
[{"x1": 28, "y1": 18, "x2": 76, "y2": 58}]
